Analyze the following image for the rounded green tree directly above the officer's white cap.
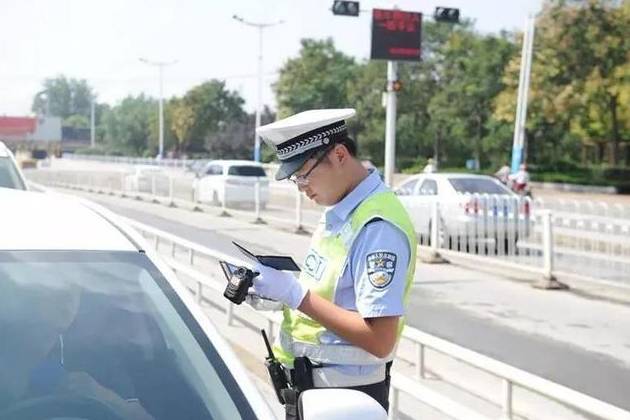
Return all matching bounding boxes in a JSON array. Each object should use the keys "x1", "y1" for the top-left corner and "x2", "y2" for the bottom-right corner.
[{"x1": 273, "y1": 38, "x2": 356, "y2": 118}]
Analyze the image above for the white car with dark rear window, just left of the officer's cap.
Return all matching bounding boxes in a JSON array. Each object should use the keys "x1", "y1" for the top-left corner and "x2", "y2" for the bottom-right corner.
[{"x1": 197, "y1": 160, "x2": 269, "y2": 208}]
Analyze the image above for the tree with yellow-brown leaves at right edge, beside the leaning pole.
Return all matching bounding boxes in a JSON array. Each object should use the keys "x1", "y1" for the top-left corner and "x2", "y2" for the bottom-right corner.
[{"x1": 495, "y1": 0, "x2": 630, "y2": 164}]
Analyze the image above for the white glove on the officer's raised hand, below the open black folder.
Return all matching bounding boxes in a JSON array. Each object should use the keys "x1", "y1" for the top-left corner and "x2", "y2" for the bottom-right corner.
[{"x1": 254, "y1": 263, "x2": 308, "y2": 309}]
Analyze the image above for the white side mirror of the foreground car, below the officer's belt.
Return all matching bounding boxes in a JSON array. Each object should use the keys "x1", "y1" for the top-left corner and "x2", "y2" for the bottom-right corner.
[{"x1": 299, "y1": 388, "x2": 387, "y2": 420}]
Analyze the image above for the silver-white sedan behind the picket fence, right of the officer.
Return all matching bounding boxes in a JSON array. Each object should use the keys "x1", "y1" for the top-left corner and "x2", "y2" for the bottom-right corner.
[{"x1": 394, "y1": 173, "x2": 530, "y2": 246}]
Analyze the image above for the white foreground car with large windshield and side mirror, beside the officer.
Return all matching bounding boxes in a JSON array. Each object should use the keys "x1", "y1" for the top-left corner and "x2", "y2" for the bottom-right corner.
[{"x1": 0, "y1": 188, "x2": 386, "y2": 420}]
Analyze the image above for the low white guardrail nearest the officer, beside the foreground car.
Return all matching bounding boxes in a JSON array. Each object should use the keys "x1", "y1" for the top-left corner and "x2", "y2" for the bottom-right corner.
[{"x1": 124, "y1": 219, "x2": 630, "y2": 420}]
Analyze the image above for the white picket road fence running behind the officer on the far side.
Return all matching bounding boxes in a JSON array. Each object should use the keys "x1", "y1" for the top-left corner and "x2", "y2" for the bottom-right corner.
[{"x1": 29, "y1": 170, "x2": 630, "y2": 287}]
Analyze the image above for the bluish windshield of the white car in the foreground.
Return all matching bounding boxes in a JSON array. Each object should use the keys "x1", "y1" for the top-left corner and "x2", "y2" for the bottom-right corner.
[{"x1": 0, "y1": 251, "x2": 254, "y2": 420}]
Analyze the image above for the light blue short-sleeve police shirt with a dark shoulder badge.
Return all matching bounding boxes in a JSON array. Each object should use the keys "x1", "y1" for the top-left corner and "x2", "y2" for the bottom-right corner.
[{"x1": 314, "y1": 170, "x2": 411, "y2": 375}]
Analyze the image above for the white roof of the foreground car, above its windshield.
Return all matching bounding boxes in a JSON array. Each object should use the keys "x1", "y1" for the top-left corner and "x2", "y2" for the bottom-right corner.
[{"x1": 0, "y1": 188, "x2": 138, "y2": 251}]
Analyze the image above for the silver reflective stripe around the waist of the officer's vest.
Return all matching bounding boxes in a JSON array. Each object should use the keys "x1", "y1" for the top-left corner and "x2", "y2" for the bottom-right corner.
[{"x1": 280, "y1": 330, "x2": 396, "y2": 365}]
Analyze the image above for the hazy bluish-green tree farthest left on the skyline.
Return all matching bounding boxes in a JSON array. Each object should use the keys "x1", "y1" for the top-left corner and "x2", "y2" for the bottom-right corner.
[{"x1": 31, "y1": 75, "x2": 95, "y2": 119}]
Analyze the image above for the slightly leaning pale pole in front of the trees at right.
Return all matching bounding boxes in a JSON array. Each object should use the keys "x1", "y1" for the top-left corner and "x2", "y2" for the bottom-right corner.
[{"x1": 511, "y1": 15, "x2": 535, "y2": 173}]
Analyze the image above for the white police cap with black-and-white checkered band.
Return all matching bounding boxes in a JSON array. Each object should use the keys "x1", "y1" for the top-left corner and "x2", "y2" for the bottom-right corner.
[{"x1": 256, "y1": 108, "x2": 356, "y2": 180}]
